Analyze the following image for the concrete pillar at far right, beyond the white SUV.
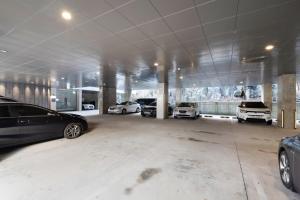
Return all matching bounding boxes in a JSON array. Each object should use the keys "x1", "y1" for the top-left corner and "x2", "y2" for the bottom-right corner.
[{"x1": 277, "y1": 74, "x2": 296, "y2": 129}]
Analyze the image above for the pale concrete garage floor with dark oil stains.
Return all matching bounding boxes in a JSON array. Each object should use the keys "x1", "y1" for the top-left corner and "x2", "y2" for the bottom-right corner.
[{"x1": 0, "y1": 115, "x2": 300, "y2": 200}]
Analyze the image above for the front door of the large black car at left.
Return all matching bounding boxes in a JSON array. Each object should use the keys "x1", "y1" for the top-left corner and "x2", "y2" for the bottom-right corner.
[{"x1": 12, "y1": 105, "x2": 57, "y2": 143}]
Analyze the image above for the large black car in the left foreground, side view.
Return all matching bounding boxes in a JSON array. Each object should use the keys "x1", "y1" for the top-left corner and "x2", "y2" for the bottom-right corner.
[{"x1": 0, "y1": 103, "x2": 88, "y2": 148}]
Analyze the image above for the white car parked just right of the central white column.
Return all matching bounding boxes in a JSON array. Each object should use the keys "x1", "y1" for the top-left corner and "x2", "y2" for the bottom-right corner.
[{"x1": 173, "y1": 102, "x2": 200, "y2": 119}]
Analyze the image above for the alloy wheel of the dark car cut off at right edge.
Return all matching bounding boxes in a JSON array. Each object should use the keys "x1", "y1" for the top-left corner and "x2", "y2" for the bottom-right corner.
[{"x1": 279, "y1": 151, "x2": 294, "y2": 190}]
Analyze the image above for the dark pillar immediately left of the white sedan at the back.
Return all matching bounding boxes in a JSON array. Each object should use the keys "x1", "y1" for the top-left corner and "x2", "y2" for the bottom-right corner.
[{"x1": 98, "y1": 86, "x2": 117, "y2": 115}]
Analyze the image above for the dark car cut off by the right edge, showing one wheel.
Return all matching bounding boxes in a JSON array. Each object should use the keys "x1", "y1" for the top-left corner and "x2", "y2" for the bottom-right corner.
[{"x1": 278, "y1": 135, "x2": 300, "y2": 192}]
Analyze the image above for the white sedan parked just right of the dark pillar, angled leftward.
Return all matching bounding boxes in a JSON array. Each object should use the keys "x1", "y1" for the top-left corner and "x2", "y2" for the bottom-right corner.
[{"x1": 108, "y1": 101, "x2": 141, "y2": 114}]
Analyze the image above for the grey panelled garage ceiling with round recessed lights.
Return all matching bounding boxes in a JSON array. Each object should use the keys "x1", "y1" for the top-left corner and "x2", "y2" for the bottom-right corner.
[{"x1": 0, "y1": 0, "x2": 300, "y2": 89}]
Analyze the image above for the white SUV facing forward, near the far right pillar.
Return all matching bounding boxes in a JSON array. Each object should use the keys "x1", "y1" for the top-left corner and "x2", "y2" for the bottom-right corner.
[{"x1": 236, "y1": 101, "x2": 272, "y2": 125}]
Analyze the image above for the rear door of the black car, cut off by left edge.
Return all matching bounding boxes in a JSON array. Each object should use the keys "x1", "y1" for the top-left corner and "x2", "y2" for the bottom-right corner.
[{"x1": 0, "y1": 105, "x2": 22, "y2": 148}]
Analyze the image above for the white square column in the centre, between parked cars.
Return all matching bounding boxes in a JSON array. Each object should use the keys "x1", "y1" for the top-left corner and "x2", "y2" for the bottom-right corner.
[{"x1": 156, "y1": 66, "x2": 169, "y2": 119}]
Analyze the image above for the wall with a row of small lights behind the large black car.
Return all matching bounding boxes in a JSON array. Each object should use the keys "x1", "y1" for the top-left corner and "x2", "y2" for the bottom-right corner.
[{"x1": 0, "y1": 82, "x2": 50, "y2": 108}]
